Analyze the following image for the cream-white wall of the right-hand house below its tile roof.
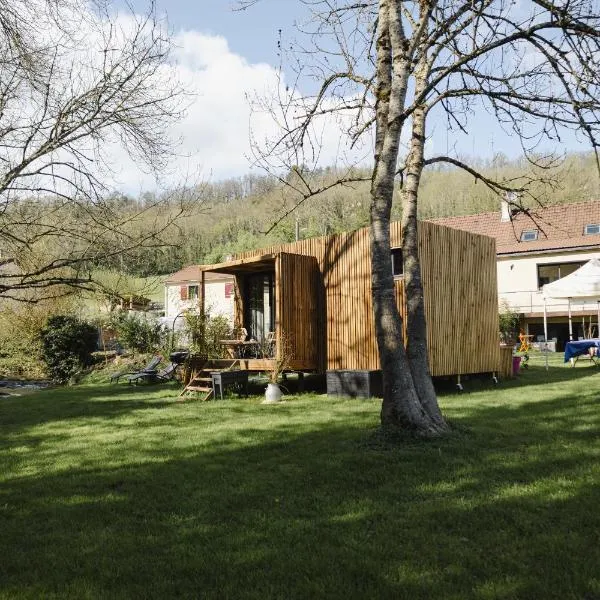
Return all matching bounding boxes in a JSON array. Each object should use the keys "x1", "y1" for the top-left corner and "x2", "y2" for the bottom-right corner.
[{"x1": 498, "y1": 251, "x2": 600, "y2": 313}]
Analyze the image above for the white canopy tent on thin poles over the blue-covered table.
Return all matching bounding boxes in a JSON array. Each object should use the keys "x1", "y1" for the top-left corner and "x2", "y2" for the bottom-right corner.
[{"x1": 542, "y1": 258, "x2": 600, "y2": 360}]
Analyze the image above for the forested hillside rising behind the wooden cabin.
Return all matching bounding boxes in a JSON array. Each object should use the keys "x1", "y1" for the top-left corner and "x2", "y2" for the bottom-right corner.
[{"x1": 139, "y1": 153, "x2": 600, "y2": 275}]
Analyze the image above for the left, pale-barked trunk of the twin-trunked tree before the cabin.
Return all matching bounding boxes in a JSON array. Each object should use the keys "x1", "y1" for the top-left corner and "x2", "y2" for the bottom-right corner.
[{"x1": 371, "y1": 0, "x2": 438, "y2": 434}]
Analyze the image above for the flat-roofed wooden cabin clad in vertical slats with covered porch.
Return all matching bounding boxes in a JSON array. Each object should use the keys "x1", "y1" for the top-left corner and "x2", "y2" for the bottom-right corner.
[{"x1": 201, "y1": 222, "x2": 499, "y2": 376}]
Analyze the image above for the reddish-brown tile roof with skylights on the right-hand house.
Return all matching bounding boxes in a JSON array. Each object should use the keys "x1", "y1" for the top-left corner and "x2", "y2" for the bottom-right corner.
[{"x1": 431, "y1": 200, "x2": 600, "y2": 255}]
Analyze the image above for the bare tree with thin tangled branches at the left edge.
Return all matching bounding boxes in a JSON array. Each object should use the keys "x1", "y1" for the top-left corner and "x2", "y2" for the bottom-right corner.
[{"x1": 0, "y1": 0, "x2": 202, "y2": 299}]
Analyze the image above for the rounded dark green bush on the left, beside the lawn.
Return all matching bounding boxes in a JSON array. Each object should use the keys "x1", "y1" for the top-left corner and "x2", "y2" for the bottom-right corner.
[{"x1": 40, "y1": 315, "x2": 98, "y2": 383}]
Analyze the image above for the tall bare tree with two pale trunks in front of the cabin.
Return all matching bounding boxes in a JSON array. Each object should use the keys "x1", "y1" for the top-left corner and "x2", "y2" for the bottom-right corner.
[{"x1": 242, "y1": 0, "x2": 600, "y2": 435}]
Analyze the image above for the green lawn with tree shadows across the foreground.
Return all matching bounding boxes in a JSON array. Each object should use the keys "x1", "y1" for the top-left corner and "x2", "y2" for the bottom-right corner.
[{"x1": 0, "y1": 362, "x2": 600, "y2": 600}]
